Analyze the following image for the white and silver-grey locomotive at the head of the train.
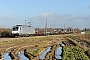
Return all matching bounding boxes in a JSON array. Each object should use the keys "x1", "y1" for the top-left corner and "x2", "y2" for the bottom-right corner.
[{"x1": 12, "y1": 25, "x2": 35, "y2": 36}]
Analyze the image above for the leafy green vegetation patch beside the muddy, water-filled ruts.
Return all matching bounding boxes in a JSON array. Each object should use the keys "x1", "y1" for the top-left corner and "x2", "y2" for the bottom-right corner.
[{"x1": 62, "y1": 46, "x2": 89, "y2": 60}]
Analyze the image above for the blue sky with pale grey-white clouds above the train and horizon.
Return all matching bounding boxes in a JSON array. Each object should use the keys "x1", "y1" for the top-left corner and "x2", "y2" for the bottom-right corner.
[{"x1": 0, "y1": 0, "x2": 90, "y2": 29}]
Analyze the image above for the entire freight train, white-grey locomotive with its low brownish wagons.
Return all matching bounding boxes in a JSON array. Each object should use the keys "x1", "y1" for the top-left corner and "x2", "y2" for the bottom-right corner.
[{"x1": 12, "y1": 25, "x2": 78, "y2": 36}]
